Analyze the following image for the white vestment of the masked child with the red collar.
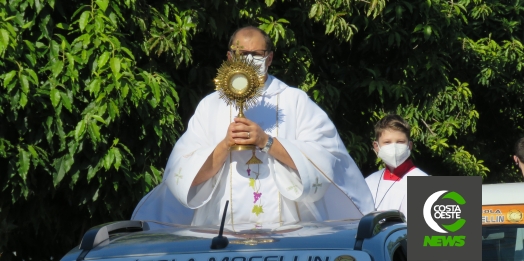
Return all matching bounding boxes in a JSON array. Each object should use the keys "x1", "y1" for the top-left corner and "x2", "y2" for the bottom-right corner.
[{"x1": 366, "y1": 168, "x2": 428, "y2": 219}]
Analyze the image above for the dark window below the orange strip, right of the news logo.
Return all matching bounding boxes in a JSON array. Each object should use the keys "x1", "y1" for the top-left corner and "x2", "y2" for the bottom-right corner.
[{"x1": 482, "y1": 224, "x2": 524, "y2": 261}]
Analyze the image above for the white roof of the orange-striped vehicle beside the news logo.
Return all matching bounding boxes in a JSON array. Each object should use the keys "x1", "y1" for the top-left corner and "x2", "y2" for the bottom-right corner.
[{"x1": 482, "y1": 183, "x2": 524, "y2": 206}]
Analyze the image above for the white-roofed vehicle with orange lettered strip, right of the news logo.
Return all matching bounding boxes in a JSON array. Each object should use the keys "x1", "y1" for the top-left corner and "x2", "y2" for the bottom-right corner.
[{"x1": 482, "y1": 183, "x2": 524, "y2": 261}]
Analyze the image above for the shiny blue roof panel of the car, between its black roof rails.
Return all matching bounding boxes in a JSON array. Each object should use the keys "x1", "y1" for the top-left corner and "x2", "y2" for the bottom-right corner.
[{"x1": 69, "y1": 220, "x2": 364, "y2": 260}]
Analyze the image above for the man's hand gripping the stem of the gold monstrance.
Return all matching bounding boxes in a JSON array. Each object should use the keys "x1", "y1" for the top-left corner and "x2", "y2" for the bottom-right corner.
[{"x1": 226, "y1": 117, "x2": 268, "y2": 148}]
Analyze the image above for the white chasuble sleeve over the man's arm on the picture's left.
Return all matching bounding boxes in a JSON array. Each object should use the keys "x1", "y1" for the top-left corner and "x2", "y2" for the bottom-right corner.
[{"x1": 164, "y1": 96, "x2": 224, "y2": 209}]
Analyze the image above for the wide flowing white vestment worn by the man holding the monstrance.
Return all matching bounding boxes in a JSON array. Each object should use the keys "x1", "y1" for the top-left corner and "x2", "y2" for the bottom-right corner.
[{"x1": 132, "y1": 75, "x2": 373, "y2": 225}]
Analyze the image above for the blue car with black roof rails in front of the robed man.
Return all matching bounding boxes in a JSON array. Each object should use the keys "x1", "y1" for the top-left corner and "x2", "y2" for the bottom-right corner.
[{"x1": 62, "y1": 211, "x2": 407, "y2": 261}]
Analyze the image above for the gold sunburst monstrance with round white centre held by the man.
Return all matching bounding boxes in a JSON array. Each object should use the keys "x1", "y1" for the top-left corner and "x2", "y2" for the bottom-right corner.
[{"x1": 215, "y1": 44, "x2": 264, "y2": 164}]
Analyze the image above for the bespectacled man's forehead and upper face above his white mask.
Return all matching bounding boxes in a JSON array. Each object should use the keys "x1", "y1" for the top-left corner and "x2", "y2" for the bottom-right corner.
[{"x1": 227, "y1": 28, "x2": 273, "y2": 72}]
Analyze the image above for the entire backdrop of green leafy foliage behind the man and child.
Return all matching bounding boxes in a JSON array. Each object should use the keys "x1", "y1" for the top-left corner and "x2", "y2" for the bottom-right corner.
[{"x1": 0, "y1": 0, "x2": 524, "y2": 259}]
